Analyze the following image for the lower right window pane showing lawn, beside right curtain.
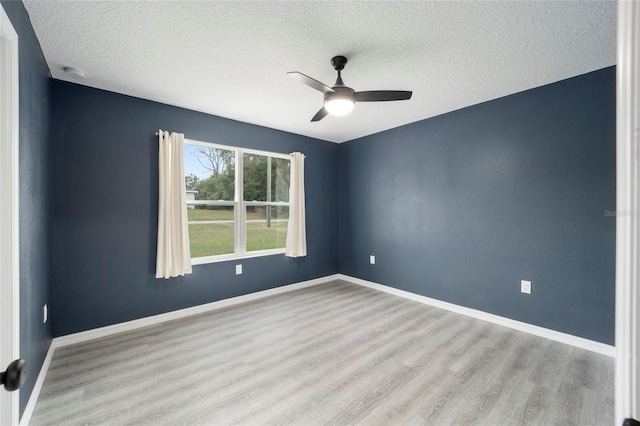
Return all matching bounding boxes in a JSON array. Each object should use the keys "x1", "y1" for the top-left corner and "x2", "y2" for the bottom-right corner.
[{"x1": 247, "y1": 206, "x2": 289, "y2": 251}]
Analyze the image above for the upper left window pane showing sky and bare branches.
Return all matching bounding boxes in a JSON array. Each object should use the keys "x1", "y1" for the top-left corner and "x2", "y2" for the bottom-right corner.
[{"x1": 184, "y1": 143, "x2": 236, "y2": 201}]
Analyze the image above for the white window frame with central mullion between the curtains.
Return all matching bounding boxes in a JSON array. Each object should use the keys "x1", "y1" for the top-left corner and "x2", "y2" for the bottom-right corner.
[{"x1": 184, "y1": 138, "x2": 291, "y2": 265}]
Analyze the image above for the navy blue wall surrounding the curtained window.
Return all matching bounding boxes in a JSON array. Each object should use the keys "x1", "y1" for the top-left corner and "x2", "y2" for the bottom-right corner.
[{"x1": 51, "y1": 80, "x2": 338, "y2": 336}]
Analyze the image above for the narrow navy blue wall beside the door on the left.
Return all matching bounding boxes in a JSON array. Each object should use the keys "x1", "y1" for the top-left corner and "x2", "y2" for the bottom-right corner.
[{"x1": 2, "y1": 0, "x2": 51, "y2": 414}]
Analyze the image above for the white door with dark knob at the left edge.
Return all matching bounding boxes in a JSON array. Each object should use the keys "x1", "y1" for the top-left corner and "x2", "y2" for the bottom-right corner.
[{"x1": 0, "y1": 5, "x2": 20, "y2": 424}]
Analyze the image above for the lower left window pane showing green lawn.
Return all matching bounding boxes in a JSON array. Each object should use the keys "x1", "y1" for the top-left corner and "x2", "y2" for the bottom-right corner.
[{"x1": 187, "y1": 206, "x2": 234, "y2": 258}]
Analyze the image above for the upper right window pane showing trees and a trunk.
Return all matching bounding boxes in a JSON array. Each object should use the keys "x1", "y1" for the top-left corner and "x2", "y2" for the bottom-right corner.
[{"x1": 243, "y1": 153, "x2": 290, "y2": 202}]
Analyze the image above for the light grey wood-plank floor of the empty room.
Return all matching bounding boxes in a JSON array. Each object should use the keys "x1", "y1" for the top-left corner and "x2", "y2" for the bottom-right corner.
[{"x1": 31, "y1": 281, "x2": 614, "y2": 426}]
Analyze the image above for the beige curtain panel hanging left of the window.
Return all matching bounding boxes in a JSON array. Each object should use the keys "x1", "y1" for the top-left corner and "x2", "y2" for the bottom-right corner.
[{"x1": 156, "y1": 130, "x2": 191, "y2": 278}]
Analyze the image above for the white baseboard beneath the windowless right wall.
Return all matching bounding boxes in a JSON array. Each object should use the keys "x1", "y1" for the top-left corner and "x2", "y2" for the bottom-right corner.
[{"x1": 338, "y1": 274, "x2": 616, "y2": 357}]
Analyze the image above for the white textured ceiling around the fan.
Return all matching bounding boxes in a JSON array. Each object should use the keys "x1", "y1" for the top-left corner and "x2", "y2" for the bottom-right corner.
[{"x1": 24, "y1": 0, "x2": 616, "y2": 142}]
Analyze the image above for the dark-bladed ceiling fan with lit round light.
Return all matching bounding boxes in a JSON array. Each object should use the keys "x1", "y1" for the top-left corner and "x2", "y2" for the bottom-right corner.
[{"x1": 287, "y1": 56, "x2": 413, "y2": 122}]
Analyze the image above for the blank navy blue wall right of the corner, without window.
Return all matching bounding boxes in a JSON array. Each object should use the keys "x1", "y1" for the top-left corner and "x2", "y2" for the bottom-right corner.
[{"x1": 339, "y1": 67, "x2": 616, "y2": 344}]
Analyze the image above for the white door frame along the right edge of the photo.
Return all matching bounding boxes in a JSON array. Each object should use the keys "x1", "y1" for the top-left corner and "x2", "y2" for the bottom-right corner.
[{"x1": 615, "y1": 0, "x2": 640, "y2": 425}]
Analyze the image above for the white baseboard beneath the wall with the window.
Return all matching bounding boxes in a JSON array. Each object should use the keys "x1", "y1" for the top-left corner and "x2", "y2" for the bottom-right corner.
[{"x1": 54, "y1": 274, "x2": 338, "y2": 347}]
